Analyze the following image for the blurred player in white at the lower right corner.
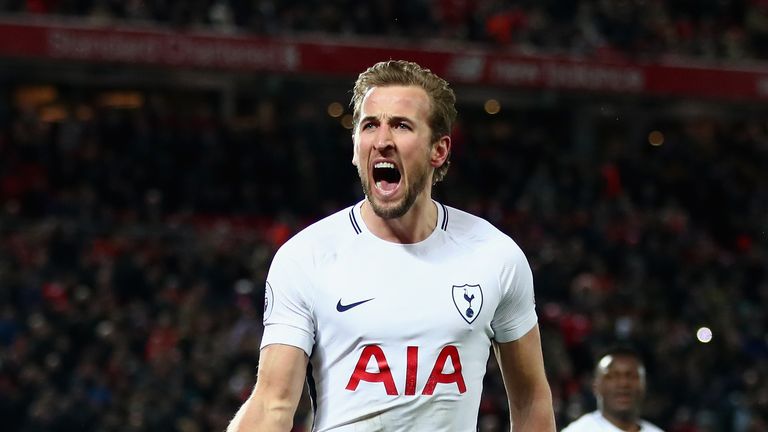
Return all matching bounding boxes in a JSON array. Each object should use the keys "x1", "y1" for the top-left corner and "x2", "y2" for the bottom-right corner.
[{"x1": 562, "y1": 348, "x2": 662, "y2": 432}]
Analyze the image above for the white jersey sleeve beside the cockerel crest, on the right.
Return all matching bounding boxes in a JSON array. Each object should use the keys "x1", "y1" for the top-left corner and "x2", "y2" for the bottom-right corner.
[{"x1": 491, "y1": 244, "x2": 538, "y2": 343}]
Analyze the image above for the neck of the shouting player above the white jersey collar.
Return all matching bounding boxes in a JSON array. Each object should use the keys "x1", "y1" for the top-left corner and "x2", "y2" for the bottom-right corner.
[{"x1": 360, "y1": 195, "x2": 437, "y2": 244}]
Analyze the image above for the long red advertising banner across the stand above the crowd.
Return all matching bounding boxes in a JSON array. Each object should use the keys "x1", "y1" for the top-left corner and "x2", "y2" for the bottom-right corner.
[{"x1": 0, "y1": 22, "x2": 768, "y2": 100}]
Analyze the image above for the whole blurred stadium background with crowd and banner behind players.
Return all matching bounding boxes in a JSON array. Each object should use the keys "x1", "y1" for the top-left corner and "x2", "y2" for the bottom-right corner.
[{"x1": 0, "y1": 0, "x2": 768, "y2": 432}]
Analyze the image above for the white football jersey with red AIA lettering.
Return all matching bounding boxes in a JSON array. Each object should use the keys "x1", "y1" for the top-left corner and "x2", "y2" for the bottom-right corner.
[{"x1": 261, "y1": 202, "x2": 537, "y2": 432}]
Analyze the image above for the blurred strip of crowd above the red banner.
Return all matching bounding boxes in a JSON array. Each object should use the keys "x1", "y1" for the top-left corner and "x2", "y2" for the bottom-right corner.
[{"x1": 0, "y1": 0, "x2": 768, "y2": 61}]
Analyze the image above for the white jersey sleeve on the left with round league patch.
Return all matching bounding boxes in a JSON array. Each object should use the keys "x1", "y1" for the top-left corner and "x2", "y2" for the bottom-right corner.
[{"x1": 261, "y1": 249, "x2": 315, "y2": 356}]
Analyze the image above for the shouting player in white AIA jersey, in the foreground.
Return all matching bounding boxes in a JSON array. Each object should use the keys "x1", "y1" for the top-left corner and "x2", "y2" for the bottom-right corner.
[{"x1": 228, "y1": 61, "x2": 555, "y2": 432}]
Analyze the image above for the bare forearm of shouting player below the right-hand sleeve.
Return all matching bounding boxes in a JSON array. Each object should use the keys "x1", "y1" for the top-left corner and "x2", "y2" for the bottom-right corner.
[{"x1": 493, "y1": 325, "x2": 555, "y2": 432}]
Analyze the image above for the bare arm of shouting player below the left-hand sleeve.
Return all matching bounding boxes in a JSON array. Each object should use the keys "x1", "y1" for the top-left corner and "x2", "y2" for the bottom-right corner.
[{"x1": 227, "y1": 344, "x2": 309, "y2": 432}]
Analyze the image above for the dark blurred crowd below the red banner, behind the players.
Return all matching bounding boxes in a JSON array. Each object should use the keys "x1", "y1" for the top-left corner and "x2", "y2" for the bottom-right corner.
[{"x1": 0, "y1": 82, "x2": 768, "y2": 432}]
